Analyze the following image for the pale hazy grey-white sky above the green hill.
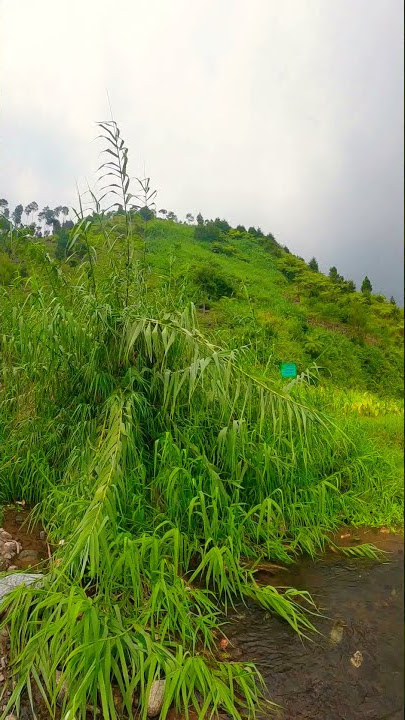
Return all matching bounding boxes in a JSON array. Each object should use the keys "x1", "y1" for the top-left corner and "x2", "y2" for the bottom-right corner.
[{"x1": 0, "y1": 0, "x2": 404, "y2": 299}]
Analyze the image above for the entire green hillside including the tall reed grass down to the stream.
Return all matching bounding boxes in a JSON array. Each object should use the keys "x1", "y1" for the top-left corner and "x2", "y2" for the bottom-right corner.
[{"x1": 0, "y1": 125, "x2": 403, "y2": 720}]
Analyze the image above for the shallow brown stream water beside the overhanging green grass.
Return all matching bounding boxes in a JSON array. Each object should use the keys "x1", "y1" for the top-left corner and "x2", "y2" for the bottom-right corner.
[{"x1": 225, "y1": 532, "x2": 404, "y2": 720}]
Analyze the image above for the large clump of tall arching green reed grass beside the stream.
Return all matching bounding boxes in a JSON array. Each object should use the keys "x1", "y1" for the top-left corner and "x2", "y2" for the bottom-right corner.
[{"x1": 0, "y1": 123, "x2": 400, "y2": 719}]
